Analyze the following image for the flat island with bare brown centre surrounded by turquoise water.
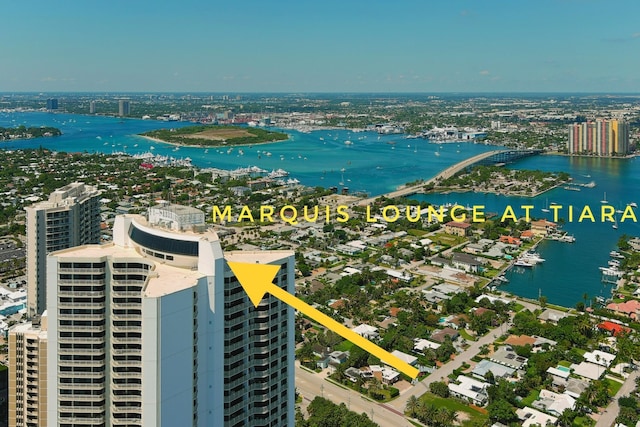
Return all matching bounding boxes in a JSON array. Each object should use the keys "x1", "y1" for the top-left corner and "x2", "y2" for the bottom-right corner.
[{"x1": 140, "y1": 125, "x2": 289, "y2": 147}]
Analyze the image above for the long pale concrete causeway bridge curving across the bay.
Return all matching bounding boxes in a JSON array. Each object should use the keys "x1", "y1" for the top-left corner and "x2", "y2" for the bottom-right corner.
[{"x1": 356, "y1": 150, "x2": 542, "y2": 206}]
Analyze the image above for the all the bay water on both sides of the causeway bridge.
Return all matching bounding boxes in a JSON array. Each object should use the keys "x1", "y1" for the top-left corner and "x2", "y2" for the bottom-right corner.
[{"x1": 0, "y1": 112, "x2": 640, "y2": 306}]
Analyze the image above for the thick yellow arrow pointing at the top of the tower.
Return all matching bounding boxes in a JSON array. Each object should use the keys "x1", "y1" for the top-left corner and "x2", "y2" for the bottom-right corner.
[{"x1": 227, "y1": 262, "x2": 419, "y2": 378}]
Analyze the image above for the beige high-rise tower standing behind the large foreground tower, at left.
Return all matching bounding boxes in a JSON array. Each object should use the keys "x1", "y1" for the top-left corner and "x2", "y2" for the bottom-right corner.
[{"x1": 25, "y1": 182, "x2": 100, "y2": 317}]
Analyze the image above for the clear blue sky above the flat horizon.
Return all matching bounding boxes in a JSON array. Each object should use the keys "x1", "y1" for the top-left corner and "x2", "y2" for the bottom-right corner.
[{"x1": 0, "y1": 0, "x2": 640, "y2": 93}]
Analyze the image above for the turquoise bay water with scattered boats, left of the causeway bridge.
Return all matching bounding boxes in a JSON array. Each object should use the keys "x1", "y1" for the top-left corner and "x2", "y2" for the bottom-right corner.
[{"x1": 0, "y1": 112, "x2": 496, "y2": 195}]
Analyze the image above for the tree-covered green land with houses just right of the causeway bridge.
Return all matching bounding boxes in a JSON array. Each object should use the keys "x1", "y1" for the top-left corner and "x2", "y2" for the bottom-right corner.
[{"x1": 433, "y1": 166, "x2": 568, "y2": 197}]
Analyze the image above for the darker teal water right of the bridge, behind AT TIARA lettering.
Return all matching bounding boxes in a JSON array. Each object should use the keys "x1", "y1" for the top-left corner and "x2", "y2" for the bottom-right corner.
[{"x1": 412, "y1": 156, "x2": 640, "y2": 307}]
